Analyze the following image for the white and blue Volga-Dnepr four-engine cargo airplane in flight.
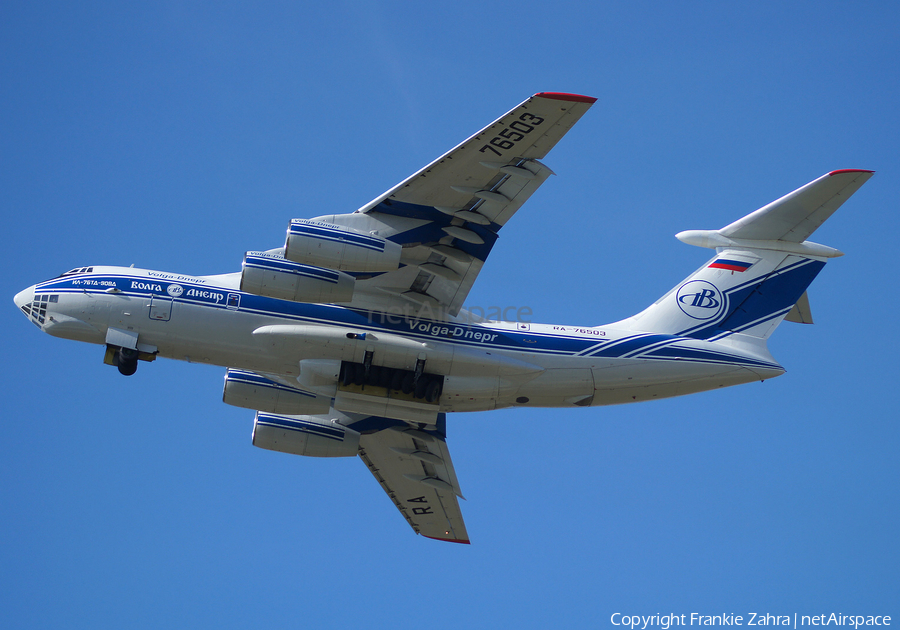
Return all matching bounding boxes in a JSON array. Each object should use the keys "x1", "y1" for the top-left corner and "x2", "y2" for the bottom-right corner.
[{"x1": 15, "y1": 92, "x2": 873, "y2": 544}]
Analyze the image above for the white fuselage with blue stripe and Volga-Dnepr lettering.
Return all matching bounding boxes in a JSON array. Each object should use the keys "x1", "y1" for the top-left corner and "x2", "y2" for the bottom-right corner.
[{"x1": 16, "y1": 267, "x2": 784, "y2": 412}]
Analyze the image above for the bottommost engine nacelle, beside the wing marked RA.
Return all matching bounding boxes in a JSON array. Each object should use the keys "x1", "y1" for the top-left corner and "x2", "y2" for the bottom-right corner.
[{"x1": 253, "y1": 412, "x2": 359, "y2": 457}]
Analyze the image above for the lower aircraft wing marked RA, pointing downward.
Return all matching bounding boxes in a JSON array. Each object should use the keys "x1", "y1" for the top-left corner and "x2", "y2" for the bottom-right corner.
[{"x1": 359, "y1": 414, "x2": 469, "y2": 544}]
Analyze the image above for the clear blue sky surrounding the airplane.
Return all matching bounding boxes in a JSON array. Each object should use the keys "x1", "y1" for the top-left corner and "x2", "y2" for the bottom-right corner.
[{"x1": 0, "y1": 1, "x2": 900, "y2": 628}]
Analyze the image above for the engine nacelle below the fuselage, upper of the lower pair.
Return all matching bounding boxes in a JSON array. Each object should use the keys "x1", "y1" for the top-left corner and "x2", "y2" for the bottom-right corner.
[{"x1": 222, "y1": 369, "x2": 331, "y2": 415}]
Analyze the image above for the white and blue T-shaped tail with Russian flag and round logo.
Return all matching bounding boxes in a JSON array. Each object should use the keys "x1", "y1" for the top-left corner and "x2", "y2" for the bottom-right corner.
[{"x1": 620, "y1": 170, "x2": 873, "y2": 341}]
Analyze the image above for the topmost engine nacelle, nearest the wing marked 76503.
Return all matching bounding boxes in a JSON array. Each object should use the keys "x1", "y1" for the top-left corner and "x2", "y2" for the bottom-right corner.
[{"x1": 284, "y1": 219, "x2": 402, "y2": 273}]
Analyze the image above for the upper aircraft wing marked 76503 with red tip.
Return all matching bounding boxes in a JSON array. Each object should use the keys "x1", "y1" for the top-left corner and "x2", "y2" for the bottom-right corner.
[{"x1": 351, "y1": 92, "x2": 597, "y2": 317}]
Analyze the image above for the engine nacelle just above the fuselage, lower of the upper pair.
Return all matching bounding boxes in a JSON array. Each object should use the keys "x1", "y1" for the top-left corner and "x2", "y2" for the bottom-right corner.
[{"x1": 241, "y1": 252, "x2": 356, "y2": 302}]
